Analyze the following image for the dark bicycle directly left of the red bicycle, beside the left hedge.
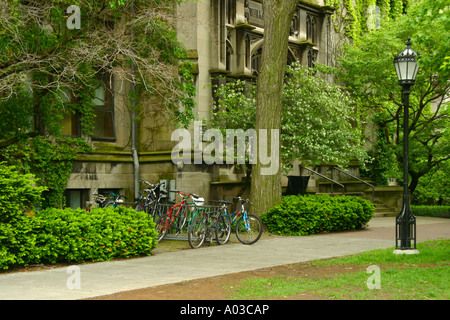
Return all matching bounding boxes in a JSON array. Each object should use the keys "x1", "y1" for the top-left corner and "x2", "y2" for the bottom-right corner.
[{"x1": 134, "y1": 179, "x2": 167, "y2": 221}]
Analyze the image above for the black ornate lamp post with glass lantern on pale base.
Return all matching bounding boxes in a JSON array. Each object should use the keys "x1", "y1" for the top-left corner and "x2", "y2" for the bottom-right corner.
[{"x1": 394, "y1": 38, "x2": 419, "y2": 254}]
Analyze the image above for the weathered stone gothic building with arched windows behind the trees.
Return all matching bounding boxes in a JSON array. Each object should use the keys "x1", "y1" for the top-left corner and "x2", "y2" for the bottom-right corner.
[{"x1": 66, "y1": 0, "x2": 400, "y2": 212}]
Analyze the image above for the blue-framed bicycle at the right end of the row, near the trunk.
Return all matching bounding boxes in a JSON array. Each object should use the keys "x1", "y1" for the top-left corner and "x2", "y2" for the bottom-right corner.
[{"x1": 228, "y1": 197, "x2": 262, "y2": 245}]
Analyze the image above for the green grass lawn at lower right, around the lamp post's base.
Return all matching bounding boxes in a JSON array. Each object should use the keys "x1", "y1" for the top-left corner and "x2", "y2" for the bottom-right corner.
[{"x1": 229, "y1": 240, "x2": 450, "y2": 300}]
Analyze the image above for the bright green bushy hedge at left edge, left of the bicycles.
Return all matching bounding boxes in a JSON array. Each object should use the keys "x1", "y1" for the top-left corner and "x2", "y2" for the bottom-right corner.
[{"x1": 0, "y1": 163, "x2": 157, "y2": 269}]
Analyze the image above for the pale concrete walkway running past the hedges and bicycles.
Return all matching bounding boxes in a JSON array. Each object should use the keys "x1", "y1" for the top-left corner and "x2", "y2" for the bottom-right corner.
[{"x1": 0, "y1": 217, "x2": 450, "y2": 300}]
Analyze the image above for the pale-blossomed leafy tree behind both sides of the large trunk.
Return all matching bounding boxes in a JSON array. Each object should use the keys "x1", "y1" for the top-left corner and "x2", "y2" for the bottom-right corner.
[{"x1": 209, "y1": 64, "x2": 366, "y2": 172}]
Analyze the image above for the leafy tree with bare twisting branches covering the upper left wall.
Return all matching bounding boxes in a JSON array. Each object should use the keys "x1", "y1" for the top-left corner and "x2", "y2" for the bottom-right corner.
[{"x1": 0, "y1": 0, "x2": 195, "y2": 207}]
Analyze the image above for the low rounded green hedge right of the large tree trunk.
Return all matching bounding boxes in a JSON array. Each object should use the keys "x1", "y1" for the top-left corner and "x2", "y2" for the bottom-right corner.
[{"x1": 261, "y1": 195, "x2": 375, "y2": 235}]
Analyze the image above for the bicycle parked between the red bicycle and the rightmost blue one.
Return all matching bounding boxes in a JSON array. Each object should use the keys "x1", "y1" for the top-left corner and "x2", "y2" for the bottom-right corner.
[{"x1": 188, "y1": 204, "x2": 231, "y2": 249}]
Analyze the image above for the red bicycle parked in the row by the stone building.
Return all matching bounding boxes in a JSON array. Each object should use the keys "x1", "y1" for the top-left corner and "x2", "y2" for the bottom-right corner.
[{"x1": 156, "y1": 190, "x2": 199, "y2": 242}]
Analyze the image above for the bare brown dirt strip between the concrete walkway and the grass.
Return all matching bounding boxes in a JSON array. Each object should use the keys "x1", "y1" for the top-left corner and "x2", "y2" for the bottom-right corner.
[{"x1": 91, "y1": 262, "x2": 364, "y2": 300}]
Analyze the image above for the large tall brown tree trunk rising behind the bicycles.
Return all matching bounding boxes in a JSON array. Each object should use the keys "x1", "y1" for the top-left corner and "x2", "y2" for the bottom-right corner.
[{"x1": 250, "y1": 0, "x2": 298, "y2": 215}]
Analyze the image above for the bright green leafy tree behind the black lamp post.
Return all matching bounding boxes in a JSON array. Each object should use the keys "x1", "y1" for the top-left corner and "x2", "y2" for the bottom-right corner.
[{"x1": 336, "y1": 0, "x2": 450, "y2": 198}]
